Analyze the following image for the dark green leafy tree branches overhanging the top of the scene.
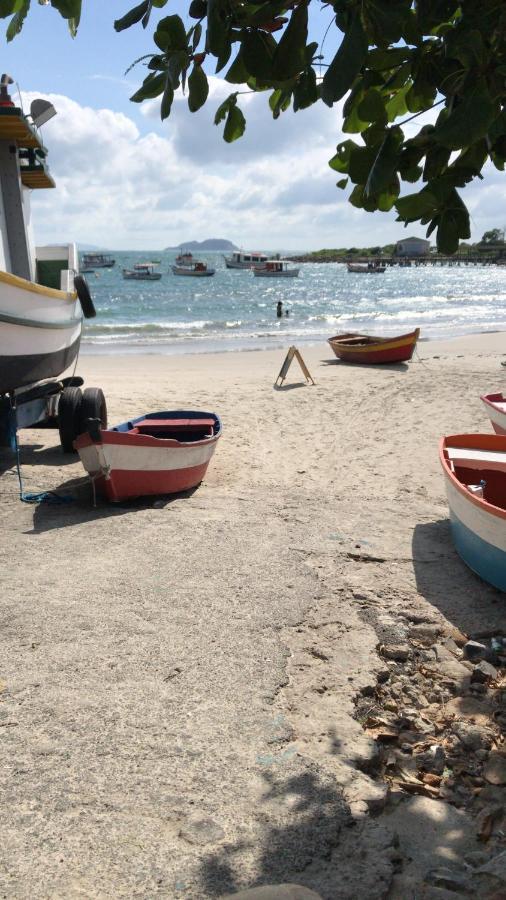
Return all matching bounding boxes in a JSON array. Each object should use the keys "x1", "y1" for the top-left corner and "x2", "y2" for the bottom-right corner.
[{"x1": 0, "y1": 0, "x2": 506, "y2": 253}]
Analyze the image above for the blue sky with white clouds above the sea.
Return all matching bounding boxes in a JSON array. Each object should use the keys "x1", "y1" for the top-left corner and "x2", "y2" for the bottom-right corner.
[{"x1": 0, "y1": 0, "x2": 506, "y2": 251}]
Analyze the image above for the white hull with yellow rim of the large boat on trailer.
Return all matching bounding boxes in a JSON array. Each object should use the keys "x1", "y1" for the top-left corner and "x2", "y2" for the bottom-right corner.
[{"x1": 0, "y1": 272, "x2": 82, "y2": 394}]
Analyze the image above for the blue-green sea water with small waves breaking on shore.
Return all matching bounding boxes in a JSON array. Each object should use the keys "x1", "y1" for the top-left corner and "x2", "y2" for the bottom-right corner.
[{"x1": 83, "y1": 251, "x2": 506, "y2": 353}]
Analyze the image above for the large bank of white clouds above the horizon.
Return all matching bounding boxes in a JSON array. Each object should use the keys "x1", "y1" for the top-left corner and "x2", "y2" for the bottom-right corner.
[{"x1": 24, "y1": 88, "x2": 506, "y2": 249}]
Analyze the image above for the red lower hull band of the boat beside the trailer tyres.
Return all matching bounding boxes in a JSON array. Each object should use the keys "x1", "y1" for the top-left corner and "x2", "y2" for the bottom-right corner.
[{"x1": 96, "y1": 461, "x2": 209, "y2": 501}]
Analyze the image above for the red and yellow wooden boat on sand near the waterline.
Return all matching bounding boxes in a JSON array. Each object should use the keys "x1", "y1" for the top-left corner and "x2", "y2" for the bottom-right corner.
[{"x1": 328, "y1": 328, "x2": 420, "y2": 365}]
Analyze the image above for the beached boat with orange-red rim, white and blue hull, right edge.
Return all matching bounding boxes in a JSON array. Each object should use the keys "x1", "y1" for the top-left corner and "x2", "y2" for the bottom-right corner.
[{"x1": 439, "y1": 434, "x2": 506, "y2": 591}]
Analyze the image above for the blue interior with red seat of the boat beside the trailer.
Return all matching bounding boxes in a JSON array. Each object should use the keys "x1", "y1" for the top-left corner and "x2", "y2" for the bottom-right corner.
[{"x1": 111, "y1": 409, "x2": 221, "y2": 444}]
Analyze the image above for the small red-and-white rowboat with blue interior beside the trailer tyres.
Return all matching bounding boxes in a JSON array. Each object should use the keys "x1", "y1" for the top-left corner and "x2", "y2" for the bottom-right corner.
[{"x1": 74, "y1": 409, "x2": 222, "y2": 501}]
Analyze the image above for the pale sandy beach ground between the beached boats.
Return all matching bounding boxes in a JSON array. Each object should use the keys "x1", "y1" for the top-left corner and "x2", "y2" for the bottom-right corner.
[{"x1": 0, "y1": 334, "x2": 506, "y2": 900}]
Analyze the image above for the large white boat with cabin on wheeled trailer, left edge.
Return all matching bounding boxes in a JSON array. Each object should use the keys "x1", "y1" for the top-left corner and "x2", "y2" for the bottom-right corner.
[{"x1": 0, "y1": 75, "x2": 106, "y2": 458}]
